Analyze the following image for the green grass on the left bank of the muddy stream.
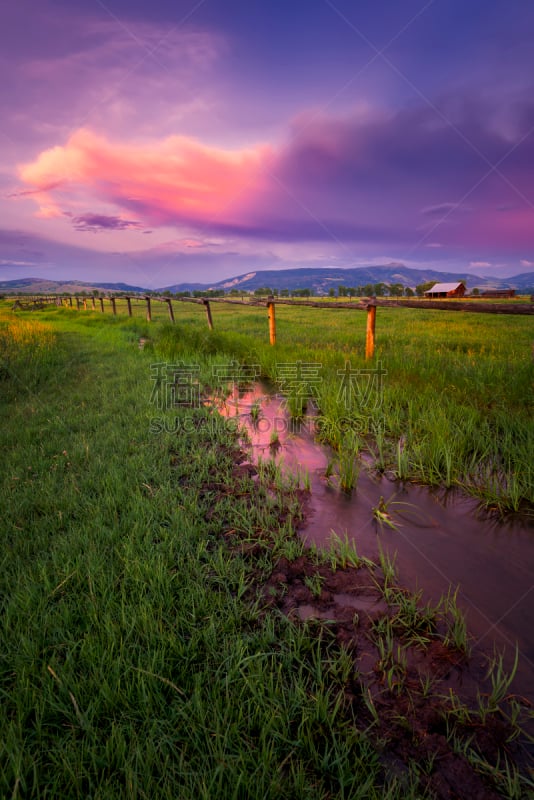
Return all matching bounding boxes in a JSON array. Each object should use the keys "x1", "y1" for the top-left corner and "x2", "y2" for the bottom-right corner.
[{"x1": 0, "y1": 304, "x2": 430, "y2": 800}]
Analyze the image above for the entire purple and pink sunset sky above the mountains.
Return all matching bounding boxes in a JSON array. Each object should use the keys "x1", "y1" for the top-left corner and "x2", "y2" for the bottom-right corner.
[{"x1": 0, "y1": 0, "x2": 534, "y2": 288}]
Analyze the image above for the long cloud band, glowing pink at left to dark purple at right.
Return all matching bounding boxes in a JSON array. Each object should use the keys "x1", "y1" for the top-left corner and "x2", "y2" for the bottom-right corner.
[{"x1": 13, "y1": 97, "x2": 534, "y2": 255}]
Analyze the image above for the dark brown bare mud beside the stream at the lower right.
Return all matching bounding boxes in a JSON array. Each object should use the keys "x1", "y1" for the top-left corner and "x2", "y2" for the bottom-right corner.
[{"x1": 263, "y1": 557, "x2": 521, "y2": 800}]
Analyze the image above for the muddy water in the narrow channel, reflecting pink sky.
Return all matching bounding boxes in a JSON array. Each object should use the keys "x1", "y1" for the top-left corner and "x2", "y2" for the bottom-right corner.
[{"x1": 216, "y1": 385, "x2": 534, "y2": 704}]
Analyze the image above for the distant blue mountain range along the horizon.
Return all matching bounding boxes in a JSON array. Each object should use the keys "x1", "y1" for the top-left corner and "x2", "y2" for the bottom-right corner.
[{"x1": 0, "y1": 264, "x2": 534, "y2": 295}]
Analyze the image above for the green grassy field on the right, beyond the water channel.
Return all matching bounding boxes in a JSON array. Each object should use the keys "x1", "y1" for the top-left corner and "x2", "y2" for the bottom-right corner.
[{"x1": 140, "y1": 296, "x2": 534, "y2": 515}]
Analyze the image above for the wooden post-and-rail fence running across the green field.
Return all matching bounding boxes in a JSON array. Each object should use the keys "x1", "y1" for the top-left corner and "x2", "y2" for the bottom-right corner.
[{"x1": 9, "y1": 295, "x2": 534, "y2": 359}]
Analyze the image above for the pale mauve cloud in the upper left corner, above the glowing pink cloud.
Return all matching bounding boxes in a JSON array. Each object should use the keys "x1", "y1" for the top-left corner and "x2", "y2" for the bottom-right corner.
[{"x1": 0, "y1": 0, "x2": 227, "y2": 144}]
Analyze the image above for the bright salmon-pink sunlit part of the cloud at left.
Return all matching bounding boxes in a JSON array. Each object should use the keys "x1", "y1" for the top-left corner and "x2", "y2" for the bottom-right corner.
[{"x1": 19, "y1": 129, "x2": 269, "y2": 224}]
